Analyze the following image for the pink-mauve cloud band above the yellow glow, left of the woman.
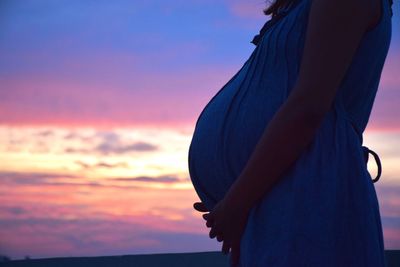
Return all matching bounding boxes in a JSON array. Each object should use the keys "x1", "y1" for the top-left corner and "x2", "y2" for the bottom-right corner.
[{"x1": 0, "y1": 55, "x2": 238, "y2": 126}]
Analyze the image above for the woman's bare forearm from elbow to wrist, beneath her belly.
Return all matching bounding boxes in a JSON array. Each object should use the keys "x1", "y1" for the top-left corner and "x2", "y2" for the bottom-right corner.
[{"x1": 226, "y1": 95, "x2": 323, "y2": 213}]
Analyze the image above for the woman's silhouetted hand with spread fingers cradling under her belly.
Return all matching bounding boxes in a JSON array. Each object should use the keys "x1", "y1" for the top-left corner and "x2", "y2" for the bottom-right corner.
[{"x1": 193, "y1": 198, "x2": 250, "y2": 266}]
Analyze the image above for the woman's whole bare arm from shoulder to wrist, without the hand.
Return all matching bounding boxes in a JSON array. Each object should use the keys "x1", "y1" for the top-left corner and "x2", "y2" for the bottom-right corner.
[{"x1": 225, "y1": 0, "x2": 374, "y2": 209}]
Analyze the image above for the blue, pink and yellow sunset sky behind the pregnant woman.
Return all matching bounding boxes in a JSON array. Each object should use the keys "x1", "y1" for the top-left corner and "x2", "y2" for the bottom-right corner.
[{"x1": 0, "y1": 0, "x2": 400, "y2": 259}]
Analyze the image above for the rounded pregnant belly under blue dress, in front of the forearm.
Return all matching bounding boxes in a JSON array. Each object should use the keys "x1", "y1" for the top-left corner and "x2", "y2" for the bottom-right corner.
[{"x1": 189, "y1": 73, "x2": 278, "y2": 209}]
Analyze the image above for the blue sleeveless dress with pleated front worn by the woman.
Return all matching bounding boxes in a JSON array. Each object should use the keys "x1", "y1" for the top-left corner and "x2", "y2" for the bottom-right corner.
[{"x1": 188, "y1": 0, "x2": 392, "y2": 267}]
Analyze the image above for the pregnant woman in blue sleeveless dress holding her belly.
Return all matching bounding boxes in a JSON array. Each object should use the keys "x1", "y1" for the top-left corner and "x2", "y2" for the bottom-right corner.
[{"x1": 188, "y1": 0, "x2": 392, "y2": 267}]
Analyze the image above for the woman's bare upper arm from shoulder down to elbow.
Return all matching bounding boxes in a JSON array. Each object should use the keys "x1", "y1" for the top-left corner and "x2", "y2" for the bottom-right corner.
[{"x1": 289, "y1": 0, "x2": 380, "y2": 118}]
